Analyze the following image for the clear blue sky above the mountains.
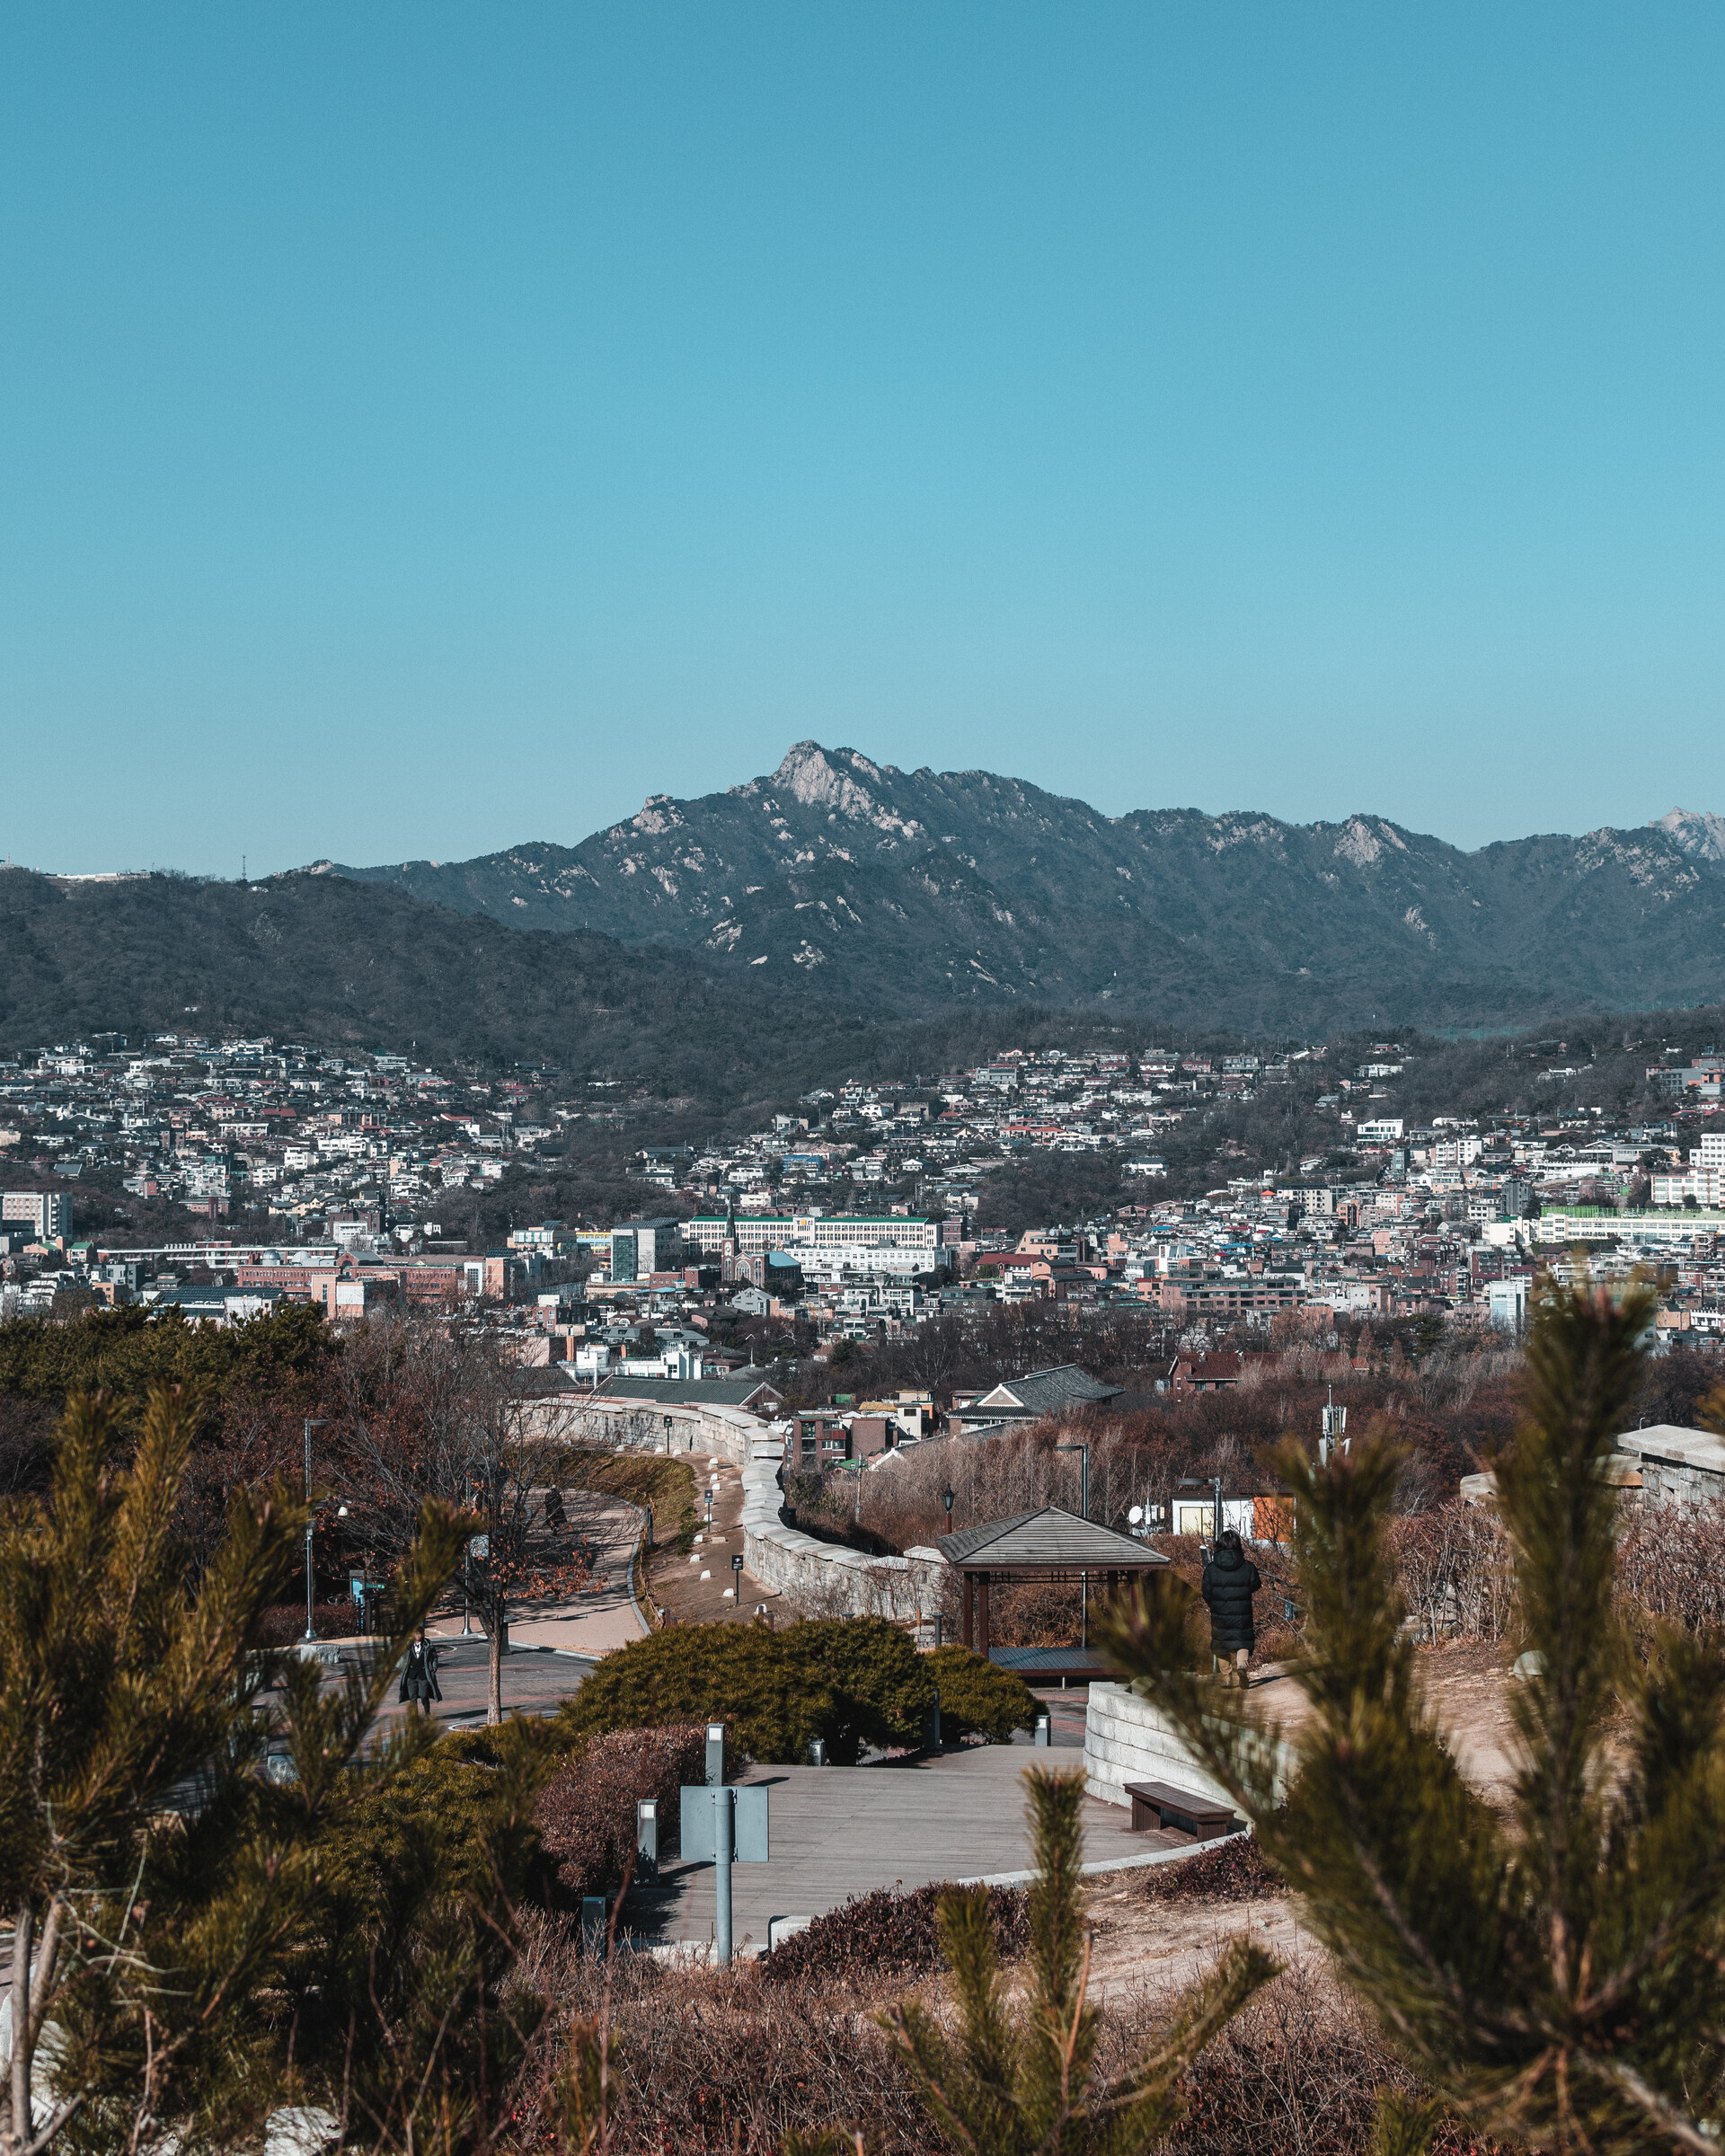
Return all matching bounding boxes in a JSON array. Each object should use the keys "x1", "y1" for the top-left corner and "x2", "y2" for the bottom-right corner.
[{"x1": 0, "y1": 0, "x2": 1725, "y2": 873}]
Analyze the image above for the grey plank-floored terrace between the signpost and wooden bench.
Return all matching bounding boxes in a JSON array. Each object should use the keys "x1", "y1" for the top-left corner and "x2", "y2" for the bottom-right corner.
[{"x1": 627, "y1": 1692, "x2": 1192, "y2": 1949}]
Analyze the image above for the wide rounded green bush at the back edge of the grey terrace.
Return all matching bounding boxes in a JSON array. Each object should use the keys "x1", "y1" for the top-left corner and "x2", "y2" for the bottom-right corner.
[{"x1": 556, "y1": 1617, "x2": 933, "y2": 1766}]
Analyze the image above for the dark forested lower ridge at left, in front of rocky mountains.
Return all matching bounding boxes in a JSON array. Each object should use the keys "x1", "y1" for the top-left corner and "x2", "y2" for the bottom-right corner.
[{"x1": 0, "y1": 869, "x2": 1121, "y2": 1112}]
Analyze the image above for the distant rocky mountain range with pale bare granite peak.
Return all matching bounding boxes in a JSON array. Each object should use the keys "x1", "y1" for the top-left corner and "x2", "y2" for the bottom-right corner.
[{"x1": 302, "y1": 742, "x2": 1725, "y2": 1035}]
